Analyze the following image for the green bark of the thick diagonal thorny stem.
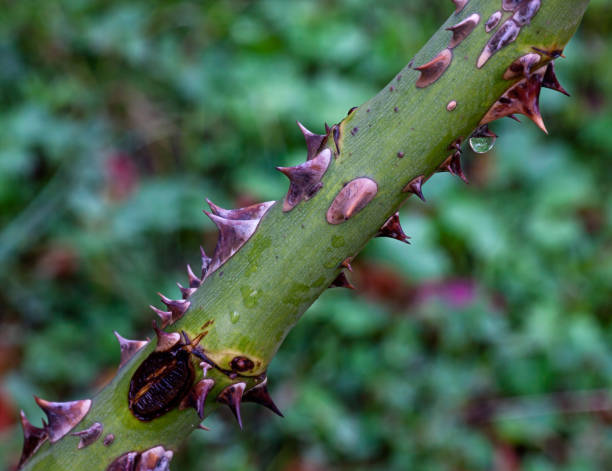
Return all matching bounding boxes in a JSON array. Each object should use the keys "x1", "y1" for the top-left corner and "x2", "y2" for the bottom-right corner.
[{"x1": 24, "y1": 0, "x2": 588, "y2": 470}]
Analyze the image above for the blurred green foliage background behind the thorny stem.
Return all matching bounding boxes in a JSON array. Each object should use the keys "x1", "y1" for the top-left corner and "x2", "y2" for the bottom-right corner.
[{"x1": 0, "y1": 0, "x2": 612, "y2": 471}]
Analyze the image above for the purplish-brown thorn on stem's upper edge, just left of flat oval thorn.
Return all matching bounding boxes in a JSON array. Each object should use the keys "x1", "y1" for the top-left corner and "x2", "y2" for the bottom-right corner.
[{"x1": 276, "y1": 149, "x2": 331, "y2": 212}]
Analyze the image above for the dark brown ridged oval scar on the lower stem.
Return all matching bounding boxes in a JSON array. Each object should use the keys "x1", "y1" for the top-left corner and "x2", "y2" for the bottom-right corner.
[{"x1": 128, "y1": 332, "x2": 210, "y2": 421}]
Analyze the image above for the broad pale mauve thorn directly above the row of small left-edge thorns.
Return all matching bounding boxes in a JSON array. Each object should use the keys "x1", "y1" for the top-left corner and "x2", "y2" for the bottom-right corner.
[{"x1": 204, "y1": 211, "x2": 259, "y2": 273}]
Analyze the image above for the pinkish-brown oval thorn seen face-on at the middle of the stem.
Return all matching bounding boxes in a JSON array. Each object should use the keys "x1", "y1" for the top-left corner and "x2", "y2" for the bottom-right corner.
[{"x1": 326, "y1": 177, "x2": 378, "y2": 224}]
